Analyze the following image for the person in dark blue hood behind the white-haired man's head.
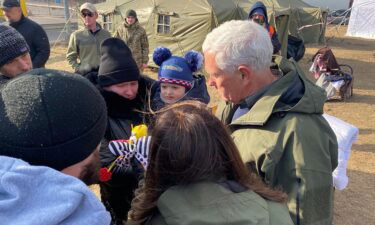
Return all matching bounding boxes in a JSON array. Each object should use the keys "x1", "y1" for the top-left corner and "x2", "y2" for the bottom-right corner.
[{"x1": 249, "y1": 1, "x2": 281, "y2": 54}]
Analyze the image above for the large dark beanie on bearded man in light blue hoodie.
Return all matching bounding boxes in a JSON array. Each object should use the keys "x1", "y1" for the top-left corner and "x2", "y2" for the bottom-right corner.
[{"x1": 0, "y1": 69, "x2": 107, "y2": 170}]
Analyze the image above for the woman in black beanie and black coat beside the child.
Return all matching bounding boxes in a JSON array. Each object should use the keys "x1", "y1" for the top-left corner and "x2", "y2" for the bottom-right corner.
[{"x1": 86, "y1": 38, "x2": 154, "y2": 224}]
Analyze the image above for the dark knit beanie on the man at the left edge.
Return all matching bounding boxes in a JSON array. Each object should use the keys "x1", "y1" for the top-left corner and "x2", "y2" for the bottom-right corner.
[{"x1": 0, "y1": 25, "x2": 29, "y2": 67}]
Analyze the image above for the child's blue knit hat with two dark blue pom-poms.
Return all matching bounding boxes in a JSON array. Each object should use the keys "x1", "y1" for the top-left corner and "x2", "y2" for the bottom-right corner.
[{"x1": 153, "y1": 47, "x2": 203, "y2": 89}]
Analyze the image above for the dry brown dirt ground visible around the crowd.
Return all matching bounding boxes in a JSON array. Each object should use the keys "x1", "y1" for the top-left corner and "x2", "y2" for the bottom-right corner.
[{"x1": 47, "y1": 26, "x2": 375, "y2": 225}]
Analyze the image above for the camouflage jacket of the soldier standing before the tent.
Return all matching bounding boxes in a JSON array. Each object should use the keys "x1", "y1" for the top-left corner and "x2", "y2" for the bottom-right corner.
[{"x1": 114, "y1": 21, "x2": 149, "y2": 68}]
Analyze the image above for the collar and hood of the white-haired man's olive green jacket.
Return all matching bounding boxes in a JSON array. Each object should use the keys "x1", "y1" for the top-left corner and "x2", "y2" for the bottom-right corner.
[{"x1": 231, "y1": 56, "x2": 326, "y2": 125}]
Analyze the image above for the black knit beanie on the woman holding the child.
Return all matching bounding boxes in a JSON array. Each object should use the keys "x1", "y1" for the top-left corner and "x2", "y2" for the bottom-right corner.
[{"x1": 98, "y1": 38, "x2": 140, "y2": 87}]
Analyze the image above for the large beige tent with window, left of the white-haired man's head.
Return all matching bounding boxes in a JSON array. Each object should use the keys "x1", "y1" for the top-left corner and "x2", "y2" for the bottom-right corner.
[{"x1": 96, "y1": 0, "x2": 247, "y2": 58}]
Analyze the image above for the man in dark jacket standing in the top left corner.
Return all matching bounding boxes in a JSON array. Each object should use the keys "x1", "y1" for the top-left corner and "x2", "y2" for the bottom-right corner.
[{"x1": 1, "y1": 0, "x2": 50, "y2": 69}]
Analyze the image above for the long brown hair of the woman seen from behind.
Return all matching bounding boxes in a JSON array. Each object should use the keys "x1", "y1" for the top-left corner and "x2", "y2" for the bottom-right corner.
[{"x1": 129, "y1": 101, "x2": 286, "y2": 224}]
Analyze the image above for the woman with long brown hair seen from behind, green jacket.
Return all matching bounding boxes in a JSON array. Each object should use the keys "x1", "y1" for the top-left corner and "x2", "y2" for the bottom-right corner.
[{"x1": 128, "y1": 101, "x2": 293, "y2": 225}]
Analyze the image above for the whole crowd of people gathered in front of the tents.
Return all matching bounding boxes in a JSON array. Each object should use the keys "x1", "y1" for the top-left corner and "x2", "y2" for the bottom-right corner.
[{"x1": 0, "y1": 0, "x2": 338, "y2": 225}]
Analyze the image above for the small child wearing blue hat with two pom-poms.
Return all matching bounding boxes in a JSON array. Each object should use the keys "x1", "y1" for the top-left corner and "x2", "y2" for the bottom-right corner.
[{"x1": 152, "y1": 47, "x2": 210, "y2": 110}]
